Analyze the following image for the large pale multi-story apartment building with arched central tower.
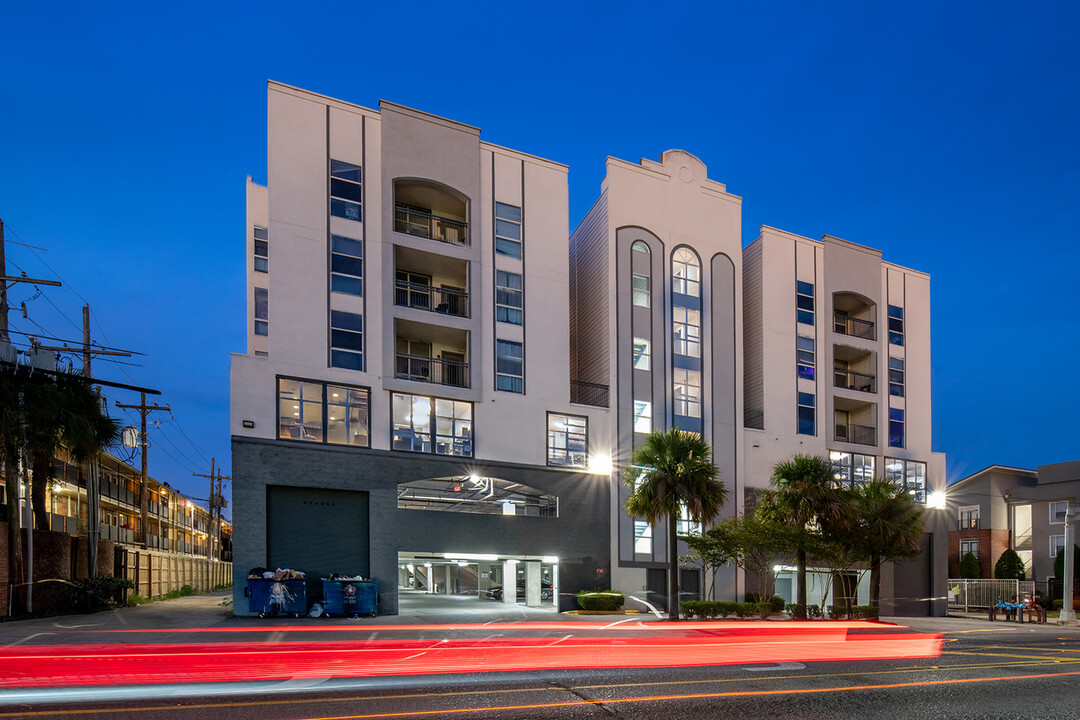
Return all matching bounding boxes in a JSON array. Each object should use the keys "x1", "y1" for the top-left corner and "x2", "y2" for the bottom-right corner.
[{"x1": 231, "y1": 83, "x2": 945, "y2": 613}]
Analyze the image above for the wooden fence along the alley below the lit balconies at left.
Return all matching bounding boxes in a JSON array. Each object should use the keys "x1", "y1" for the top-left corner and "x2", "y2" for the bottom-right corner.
[{"x1": 116, "y1": 547, "x2": 232, "y2": 598}]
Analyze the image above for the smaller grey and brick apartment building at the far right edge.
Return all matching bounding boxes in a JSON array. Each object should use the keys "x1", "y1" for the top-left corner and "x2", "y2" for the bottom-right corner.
[{"x1": 948, "y1": 461, "x2": 1080, "y2": 582}]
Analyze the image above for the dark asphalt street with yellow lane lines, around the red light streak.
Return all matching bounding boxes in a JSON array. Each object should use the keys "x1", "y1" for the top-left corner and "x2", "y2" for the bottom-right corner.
[{"x1": 0, "y1": 591, "x2": 1080, "y2": 720}]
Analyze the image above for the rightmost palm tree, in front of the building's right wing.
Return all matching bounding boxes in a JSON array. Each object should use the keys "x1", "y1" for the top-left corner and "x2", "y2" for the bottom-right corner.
[{"x1": 853, "y1": 477, "x2": 926, "y2": 607}]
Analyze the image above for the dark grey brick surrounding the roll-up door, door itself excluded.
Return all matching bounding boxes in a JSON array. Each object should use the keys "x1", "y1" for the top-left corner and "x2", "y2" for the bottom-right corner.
[{"x1": 232, "y1": 437, "x2": 611, "y2": 613}]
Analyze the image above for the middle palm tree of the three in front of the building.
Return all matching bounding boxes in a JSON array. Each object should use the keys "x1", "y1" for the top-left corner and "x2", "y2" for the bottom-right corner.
[{"x1": 765, "y1": 454, "x2": 851, "y2": 617}]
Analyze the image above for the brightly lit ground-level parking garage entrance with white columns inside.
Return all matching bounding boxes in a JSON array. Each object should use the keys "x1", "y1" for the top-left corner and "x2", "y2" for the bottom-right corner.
[{"x1": 397, "y1": 552, "x2": 558, "y2": 612}]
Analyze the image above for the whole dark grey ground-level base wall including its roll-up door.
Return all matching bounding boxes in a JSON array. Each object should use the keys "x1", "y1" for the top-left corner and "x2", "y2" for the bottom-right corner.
[{"x1": 232, "y1": 437, "x2": 610, "y2": 615}]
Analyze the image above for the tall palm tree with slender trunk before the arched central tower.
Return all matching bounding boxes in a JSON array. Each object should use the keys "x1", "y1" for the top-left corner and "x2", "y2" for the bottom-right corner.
[{"x1": 623, "y1": 427, "x2": 728, "y2": 620}]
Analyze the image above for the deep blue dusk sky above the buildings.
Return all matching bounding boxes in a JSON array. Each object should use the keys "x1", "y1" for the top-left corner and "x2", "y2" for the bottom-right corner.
[{"x1": 0, "y1": 2, "x2": 1080, "y2": 509}]
